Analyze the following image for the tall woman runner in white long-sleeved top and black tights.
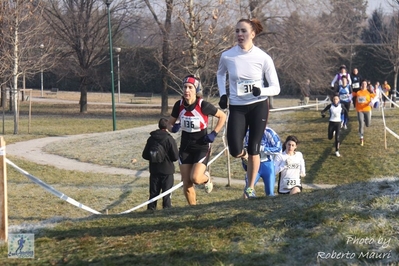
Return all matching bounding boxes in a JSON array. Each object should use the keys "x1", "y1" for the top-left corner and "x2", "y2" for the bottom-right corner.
[{"x1": 217, "y1": 19, "x2": 280, "y2": 198}]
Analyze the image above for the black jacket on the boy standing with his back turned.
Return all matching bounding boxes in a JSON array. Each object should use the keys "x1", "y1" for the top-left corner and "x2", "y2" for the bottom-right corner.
[{"x1": 142, "y1": 129, "x2": 179, "y2": 175}]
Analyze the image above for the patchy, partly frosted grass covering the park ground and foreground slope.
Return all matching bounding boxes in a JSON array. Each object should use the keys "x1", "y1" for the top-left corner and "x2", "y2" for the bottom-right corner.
[{"x1": 0, "y1": 91, "x2": 399, "y2": 265}]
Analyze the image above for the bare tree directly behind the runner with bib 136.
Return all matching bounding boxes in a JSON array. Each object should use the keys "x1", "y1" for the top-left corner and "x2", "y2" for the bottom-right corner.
[{"x1": 172, "y1": 0, "x2": 234, "y2": 95}]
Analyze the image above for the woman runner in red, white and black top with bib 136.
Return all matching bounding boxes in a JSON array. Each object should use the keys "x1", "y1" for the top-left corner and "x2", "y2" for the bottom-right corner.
[{"x1": 169, "y1": 75, "x2": 226, "y2": 205}]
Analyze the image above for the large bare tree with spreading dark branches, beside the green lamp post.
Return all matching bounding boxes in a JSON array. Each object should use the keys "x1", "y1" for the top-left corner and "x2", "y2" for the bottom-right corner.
[{"x1": 44, "y1": 0, "x2": 134, "y2": 113}]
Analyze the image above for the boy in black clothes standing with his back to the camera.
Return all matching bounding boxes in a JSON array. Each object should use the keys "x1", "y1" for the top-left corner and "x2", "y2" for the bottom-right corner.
[{"x1": 142, "y1": 118, "x2": 179, "y2": 210}]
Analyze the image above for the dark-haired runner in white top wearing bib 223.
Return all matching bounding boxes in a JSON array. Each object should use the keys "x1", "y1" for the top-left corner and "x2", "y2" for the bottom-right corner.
[{"x1": 274, "y1": 136, "x2": 306, "y2": 194}]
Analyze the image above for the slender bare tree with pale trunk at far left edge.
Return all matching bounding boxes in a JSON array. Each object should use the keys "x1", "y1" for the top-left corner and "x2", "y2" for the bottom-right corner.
[{"x1": 0, "y1": 0, "x2": 49, "y2": 134}]
